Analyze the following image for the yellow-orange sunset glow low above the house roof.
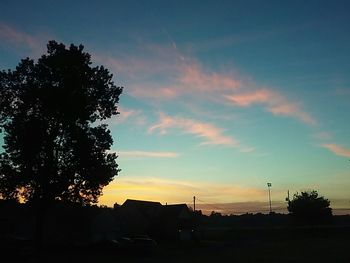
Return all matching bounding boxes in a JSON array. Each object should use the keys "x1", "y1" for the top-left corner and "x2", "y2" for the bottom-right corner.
[{"x1": 99, "y1": 178, "x2": 266, "y2": 207}]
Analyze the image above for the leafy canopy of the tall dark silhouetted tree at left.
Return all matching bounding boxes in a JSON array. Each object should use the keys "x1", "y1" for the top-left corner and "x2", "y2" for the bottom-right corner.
[{"x1": 0, "y1": 41, "x2": 122, "y2": 204}]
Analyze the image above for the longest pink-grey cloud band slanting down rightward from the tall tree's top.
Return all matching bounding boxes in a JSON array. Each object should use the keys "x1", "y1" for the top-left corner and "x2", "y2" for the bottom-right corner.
[{"x1": 97, "y1": 43, "x2": 317, "y2": 125}]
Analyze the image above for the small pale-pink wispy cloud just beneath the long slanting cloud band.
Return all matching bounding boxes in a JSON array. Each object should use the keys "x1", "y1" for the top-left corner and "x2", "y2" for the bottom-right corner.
[{"x1": 148, "y1": 113, "x2": 239, "y2": 147}]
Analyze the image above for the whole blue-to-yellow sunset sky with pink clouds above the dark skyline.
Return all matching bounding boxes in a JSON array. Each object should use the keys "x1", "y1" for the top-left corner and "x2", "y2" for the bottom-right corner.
[{"x1": 0, "y1": 0, "x2": 350, "y2": 213}]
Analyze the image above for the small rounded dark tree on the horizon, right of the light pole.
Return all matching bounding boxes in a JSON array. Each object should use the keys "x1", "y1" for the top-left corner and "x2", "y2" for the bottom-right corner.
[{"x1": 288, "y1": 190, "x2": 332, "y2": 224}]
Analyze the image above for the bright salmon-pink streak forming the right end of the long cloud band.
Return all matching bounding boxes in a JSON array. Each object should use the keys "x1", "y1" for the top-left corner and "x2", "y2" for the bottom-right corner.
[{"x1": 225, "y1": 88, "x2": 317, "y2": 125}]
